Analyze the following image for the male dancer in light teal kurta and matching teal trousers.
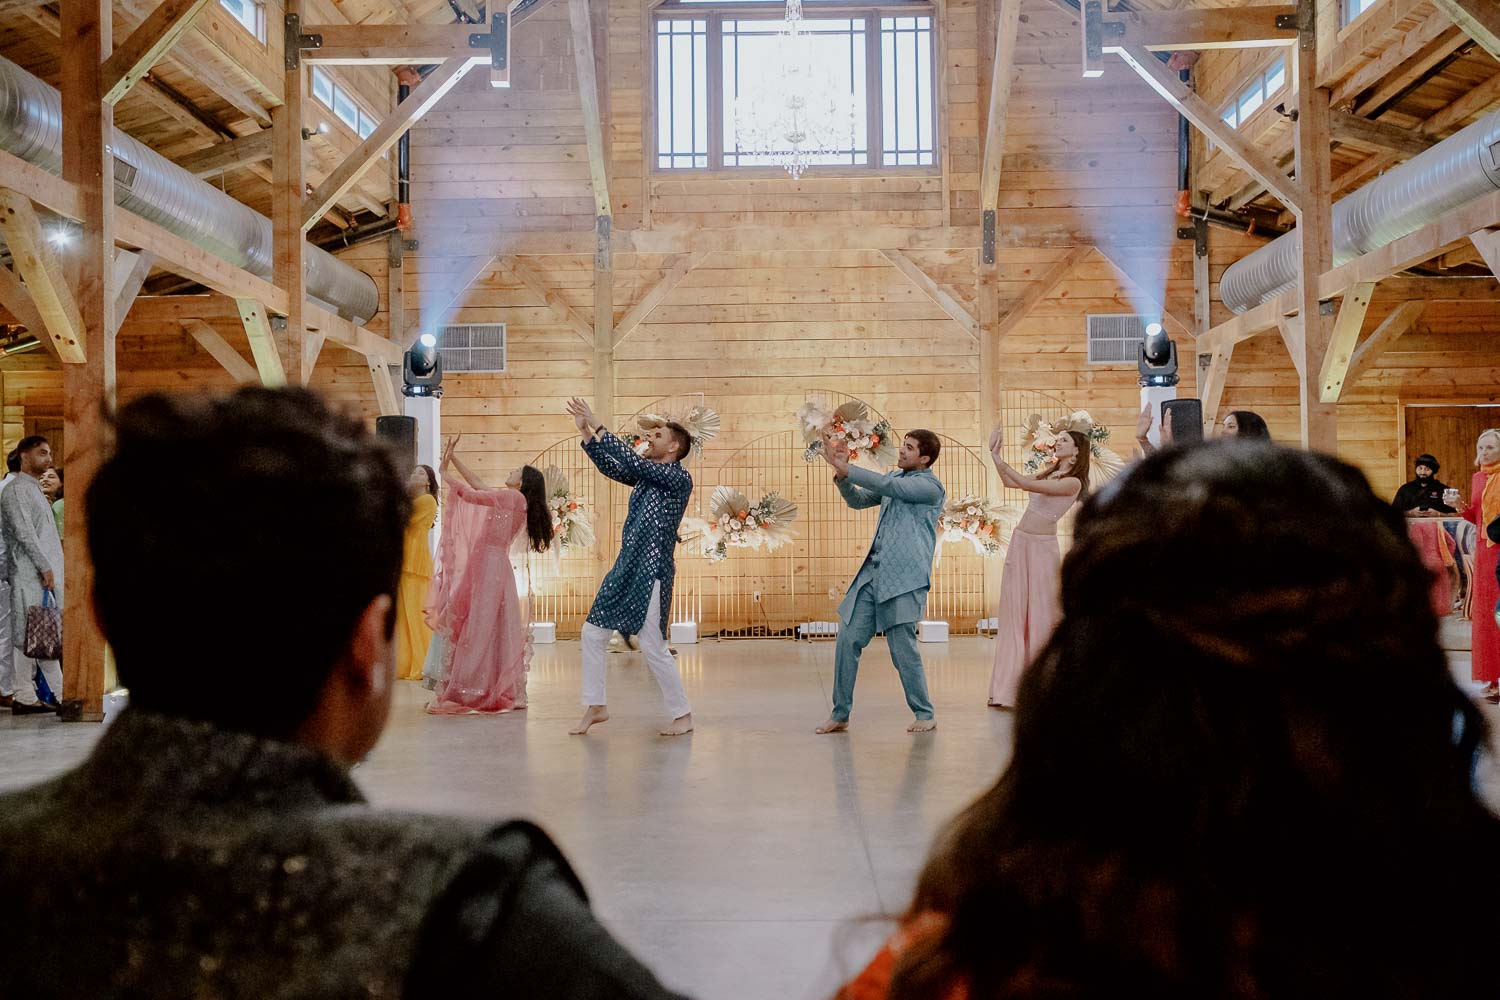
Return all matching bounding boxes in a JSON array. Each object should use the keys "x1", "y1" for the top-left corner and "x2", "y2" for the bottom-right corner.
[{"x1": 818, "y1": 430, "x2": 945, "y2": 733}]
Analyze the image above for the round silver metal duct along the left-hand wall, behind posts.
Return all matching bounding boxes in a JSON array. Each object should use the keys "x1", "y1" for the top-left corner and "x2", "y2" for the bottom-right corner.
[{"x1": 0, "y1": 58, "x2": 380, "y2": 324}]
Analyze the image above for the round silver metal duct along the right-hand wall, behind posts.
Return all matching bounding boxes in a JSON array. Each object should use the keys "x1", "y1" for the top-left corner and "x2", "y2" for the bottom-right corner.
[{"x1": 1220, "y1": 111, "x2": 1500, "y2": 312}]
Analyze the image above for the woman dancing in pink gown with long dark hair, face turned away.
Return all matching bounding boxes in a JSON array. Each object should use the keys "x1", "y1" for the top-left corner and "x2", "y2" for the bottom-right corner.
[{"x1": 426, "y1": 438, "x2": 552, "y2": 715}]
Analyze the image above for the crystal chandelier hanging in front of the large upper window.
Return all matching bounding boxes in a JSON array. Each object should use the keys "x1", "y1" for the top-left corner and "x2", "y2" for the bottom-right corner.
[{"x1": 734, "y1": 0, "x2": 855, "y2": 180}]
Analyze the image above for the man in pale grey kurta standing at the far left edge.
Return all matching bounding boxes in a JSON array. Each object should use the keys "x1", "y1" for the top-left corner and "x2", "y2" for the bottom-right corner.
[{"x1": 0, "y1": 435, "x2": 63, "y2": 712}]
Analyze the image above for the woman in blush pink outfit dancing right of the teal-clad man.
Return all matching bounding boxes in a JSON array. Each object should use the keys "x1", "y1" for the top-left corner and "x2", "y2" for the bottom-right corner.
[{"x1": 990, "y1": 427, "x2": 1089, "y2": 708}]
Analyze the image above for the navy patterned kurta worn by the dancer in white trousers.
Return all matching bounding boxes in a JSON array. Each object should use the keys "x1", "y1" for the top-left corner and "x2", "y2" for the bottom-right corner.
[{"x1": 584, "y1": 430, "x2": 693, "y2": 636}]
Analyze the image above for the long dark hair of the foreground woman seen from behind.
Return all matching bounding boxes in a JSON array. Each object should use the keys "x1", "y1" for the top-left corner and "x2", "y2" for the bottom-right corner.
[{"x1": 890, "y1": 442, "x2": 1500, "y2": 1000}]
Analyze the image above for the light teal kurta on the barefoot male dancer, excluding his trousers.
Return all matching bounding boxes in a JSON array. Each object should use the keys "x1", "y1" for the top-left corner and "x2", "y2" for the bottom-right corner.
[{"x1": 834, "y1": 465, "x2": 947, "y2": 631}]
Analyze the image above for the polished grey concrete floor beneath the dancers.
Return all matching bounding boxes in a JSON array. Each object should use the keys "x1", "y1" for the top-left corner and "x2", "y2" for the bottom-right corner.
[{"x1": 0, "y1": 639, "x2": 1500, "y2": 1000}]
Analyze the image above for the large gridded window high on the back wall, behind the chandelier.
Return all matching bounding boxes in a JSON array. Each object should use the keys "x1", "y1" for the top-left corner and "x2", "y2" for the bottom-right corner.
[{"x1": 654, "y1": 0, "x2": 938, "y2": 169}]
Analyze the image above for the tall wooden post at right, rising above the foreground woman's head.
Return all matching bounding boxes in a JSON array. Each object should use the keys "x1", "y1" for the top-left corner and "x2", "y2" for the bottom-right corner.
[{"x1": 1289, "y1": 0, "x2": 1338, "y2": 454}]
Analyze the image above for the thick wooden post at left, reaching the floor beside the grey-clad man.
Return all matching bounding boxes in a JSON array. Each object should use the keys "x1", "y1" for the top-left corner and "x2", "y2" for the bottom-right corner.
[{"x1": 62, "y1": 0, "x2": 116, "y2": 721}]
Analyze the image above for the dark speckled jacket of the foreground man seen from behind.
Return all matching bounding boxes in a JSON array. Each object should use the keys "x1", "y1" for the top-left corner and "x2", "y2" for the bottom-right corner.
[{"x1": 0, "y1": 709, "x2": 687, "y2": 1000}]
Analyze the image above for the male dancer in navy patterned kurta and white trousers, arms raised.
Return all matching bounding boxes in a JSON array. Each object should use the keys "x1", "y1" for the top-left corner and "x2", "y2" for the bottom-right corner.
[{"x1": 567, "y1": 399, "x2": 693, "y2": 736}]
